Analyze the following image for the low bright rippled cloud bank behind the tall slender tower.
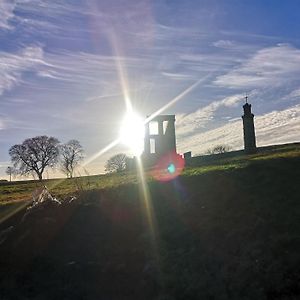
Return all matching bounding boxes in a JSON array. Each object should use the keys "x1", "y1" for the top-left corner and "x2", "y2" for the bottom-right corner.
[{"x1": 178, "y1": 105, "x2": 300, "y2": 154}]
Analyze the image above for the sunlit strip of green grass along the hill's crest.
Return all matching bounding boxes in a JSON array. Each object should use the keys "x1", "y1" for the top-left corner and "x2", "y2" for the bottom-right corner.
[{"x1": 0, "y1": 144, "x2": 300, "y2": 205}]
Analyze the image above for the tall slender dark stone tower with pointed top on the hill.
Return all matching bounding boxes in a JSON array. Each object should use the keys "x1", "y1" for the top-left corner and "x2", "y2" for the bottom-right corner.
[{"x1": 242, "y1": 96, "x2": 256, "y2": 154}]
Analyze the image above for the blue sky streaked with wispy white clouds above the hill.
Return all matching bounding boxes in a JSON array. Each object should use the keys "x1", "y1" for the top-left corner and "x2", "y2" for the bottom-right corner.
[{"x1": 0, "y1": 0, "x2": 300, "y2": 178}]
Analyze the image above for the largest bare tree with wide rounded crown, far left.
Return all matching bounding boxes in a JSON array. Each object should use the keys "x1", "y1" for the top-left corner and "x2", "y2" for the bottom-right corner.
[{"x1": 9, "y1": 135, "x2": 59, "y2": 181}]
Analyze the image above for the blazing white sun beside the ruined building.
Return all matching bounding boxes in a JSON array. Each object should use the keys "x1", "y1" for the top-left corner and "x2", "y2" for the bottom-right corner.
[{"x1": 120, "y1": 111, "x2": 145, "y2": 156}]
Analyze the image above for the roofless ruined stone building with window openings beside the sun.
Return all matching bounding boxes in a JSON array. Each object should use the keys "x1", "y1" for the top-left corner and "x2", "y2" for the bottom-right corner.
[{"x1": 143, "y1": 115, "x2": 176, "y2": 165}]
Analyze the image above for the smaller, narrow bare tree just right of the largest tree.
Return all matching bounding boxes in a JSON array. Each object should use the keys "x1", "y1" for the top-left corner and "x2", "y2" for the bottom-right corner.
[{"x1": 60, "y1": 140, "x2": 83, "y2": 178}]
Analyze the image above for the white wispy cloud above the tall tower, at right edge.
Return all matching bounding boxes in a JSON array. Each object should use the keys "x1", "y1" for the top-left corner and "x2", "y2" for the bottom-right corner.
[{"x1": 214, "y1": 44, "x2": 300, "y2": 88}]
